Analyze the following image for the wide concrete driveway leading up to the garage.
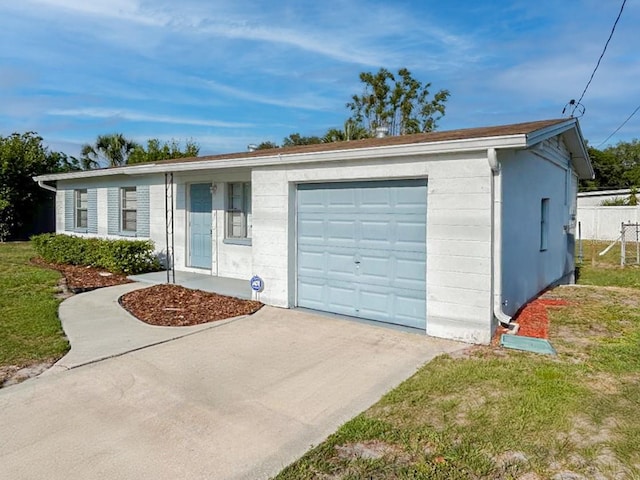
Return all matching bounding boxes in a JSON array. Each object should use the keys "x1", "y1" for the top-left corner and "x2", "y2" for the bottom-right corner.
[{"x1": 0, "y1": 307, "x2": 464, "y2": 480}]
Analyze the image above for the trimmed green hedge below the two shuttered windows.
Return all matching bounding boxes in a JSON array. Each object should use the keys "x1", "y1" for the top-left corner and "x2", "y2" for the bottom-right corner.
[{"x1": 31, "y1": 233, "x2": 160, "y2": 274}]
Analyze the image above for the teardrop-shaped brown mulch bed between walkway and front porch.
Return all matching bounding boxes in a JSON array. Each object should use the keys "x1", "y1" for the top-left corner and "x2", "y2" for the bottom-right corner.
[{"x1": 120, "y1": 284, "x2": 263, "y2": 327}]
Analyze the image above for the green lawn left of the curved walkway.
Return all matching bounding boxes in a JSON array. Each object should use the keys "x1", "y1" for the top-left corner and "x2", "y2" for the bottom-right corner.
[{"x1": 0, "y1": 242, "x2": 69, "y2": 372}]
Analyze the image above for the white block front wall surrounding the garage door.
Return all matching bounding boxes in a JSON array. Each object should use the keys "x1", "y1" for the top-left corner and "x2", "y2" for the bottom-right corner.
[{"x1": 252, "y1": 154, "x2": 492, "y2": 343}]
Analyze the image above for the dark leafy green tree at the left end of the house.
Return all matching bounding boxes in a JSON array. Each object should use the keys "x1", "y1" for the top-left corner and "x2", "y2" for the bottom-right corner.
[{"x1": 0, "y1": 132, "x2": 74, "y2": 241}]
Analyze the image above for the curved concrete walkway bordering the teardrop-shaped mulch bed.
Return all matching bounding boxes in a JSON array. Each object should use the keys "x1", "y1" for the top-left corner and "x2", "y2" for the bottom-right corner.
[{"x1": 48, "y1": 283, "x2": 235, "y2": 375}]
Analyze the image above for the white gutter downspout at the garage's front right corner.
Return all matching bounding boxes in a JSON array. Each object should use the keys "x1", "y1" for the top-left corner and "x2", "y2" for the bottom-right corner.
[{"x1": 487, "y1": 148, "x2": 514, "y2": 329}]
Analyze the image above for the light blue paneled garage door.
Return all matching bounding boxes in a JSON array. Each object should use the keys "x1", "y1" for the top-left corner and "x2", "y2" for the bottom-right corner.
[{"x1": 297, "y1": 180, "x2": 427, "y2": 329}]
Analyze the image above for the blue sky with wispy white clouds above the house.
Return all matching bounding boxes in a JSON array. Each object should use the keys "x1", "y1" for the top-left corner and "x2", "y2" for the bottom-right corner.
[{"x1": 0, "y1": 0, "x2": 640, "y2": 155}]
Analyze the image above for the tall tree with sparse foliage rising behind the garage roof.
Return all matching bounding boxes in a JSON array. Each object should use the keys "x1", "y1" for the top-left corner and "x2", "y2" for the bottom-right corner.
[{"x1": 347, "y1": 68, "x2": 449, "y2": 135}]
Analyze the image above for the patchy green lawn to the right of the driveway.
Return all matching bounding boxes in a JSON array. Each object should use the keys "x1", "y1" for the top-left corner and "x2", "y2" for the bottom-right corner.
[{"x1": 276, "y1": 262, "x2": 640, "y2": 480}]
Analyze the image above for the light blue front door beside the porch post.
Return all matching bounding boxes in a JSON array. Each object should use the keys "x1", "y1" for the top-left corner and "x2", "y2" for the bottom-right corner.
[{"x1": 189, "y1": 183, "x2": 212, "y2": 269}]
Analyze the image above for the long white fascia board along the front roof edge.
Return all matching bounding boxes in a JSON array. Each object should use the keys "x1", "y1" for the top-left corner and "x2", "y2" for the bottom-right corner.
[{"x1": 34, "y1": 134, "x2": 527, "y2": 181}]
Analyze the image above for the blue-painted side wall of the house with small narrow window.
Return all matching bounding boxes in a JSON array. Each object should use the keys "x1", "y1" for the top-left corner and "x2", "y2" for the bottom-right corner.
[{"x1": 498, "y1": 139, "x2": 577, "y2": 315}]
